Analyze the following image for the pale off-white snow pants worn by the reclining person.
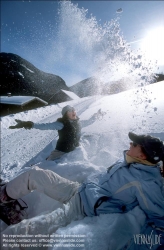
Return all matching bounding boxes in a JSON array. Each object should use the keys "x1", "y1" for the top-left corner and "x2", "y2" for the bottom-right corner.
[{"x1": 6, "y1": 166, "x2": 84, "y2": 234}]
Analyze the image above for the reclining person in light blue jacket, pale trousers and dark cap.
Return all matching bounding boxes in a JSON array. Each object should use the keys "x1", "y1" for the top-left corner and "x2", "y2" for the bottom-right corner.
[{"x1": 0, "y1": 132, "x2": 164, "y2": 250}]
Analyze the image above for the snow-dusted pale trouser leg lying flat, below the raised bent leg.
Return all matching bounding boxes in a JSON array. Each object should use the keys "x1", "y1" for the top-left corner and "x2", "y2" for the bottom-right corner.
[{"x1": 3, "y1": 193, "x2": 84, "y2": 241}]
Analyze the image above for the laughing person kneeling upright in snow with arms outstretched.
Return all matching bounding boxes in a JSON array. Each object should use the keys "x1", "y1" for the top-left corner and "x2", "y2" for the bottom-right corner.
[{"x1": 9, "y1": 105, "x2": 81, "y2": 161}]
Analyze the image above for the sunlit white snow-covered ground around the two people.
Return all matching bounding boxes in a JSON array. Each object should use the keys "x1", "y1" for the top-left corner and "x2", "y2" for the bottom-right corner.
[{"x1": 1, "y1": 81, "x2": 164, "y2": 250}]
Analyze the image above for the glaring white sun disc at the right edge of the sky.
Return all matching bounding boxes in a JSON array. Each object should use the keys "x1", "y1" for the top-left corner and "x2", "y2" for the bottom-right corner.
[{"x1": 141, "y1": 27, "x2": 164, "y2": 65}]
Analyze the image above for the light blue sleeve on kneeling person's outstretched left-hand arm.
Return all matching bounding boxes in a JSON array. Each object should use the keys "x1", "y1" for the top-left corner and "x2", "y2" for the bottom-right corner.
[{"x1": 33, "y1": 121, "x2": 64, "y2": 130}]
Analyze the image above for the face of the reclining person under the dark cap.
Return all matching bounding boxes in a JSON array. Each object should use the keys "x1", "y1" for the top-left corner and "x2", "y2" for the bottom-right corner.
[{"x1": 127, "y1": 142, "x2": 146, "y2": 160}]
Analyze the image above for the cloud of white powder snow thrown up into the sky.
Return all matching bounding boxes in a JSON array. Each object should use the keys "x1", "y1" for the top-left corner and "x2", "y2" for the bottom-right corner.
[{"x1": 57, "y1": 1, "x2": 156, "y2": 89}]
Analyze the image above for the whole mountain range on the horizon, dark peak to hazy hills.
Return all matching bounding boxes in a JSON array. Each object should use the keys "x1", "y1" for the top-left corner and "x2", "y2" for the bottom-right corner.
[{"x1": 0, "y1": 52, "x2": 164, "y2": 103}]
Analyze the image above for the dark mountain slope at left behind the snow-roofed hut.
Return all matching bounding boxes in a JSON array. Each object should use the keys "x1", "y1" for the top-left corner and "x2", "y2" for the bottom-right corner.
[{"x1": 0, "y1": 53, "x2": 69, "y2": 103}]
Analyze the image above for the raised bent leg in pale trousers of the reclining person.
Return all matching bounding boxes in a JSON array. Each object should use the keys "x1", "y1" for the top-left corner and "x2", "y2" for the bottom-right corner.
[{"x1": 6, "y1": 166, "x2": 79, "y2": 203}]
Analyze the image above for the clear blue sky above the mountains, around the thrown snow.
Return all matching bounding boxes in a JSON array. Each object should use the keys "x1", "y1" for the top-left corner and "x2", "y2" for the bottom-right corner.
[{"x1": 1, "y1": 0, "x2": 164, "y2": 85}]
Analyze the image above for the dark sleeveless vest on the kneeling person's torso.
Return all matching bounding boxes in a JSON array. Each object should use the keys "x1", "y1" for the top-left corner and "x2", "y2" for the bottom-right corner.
[{"x1": 56, "y1": 118, "x2": 81, "y2": 153}]
